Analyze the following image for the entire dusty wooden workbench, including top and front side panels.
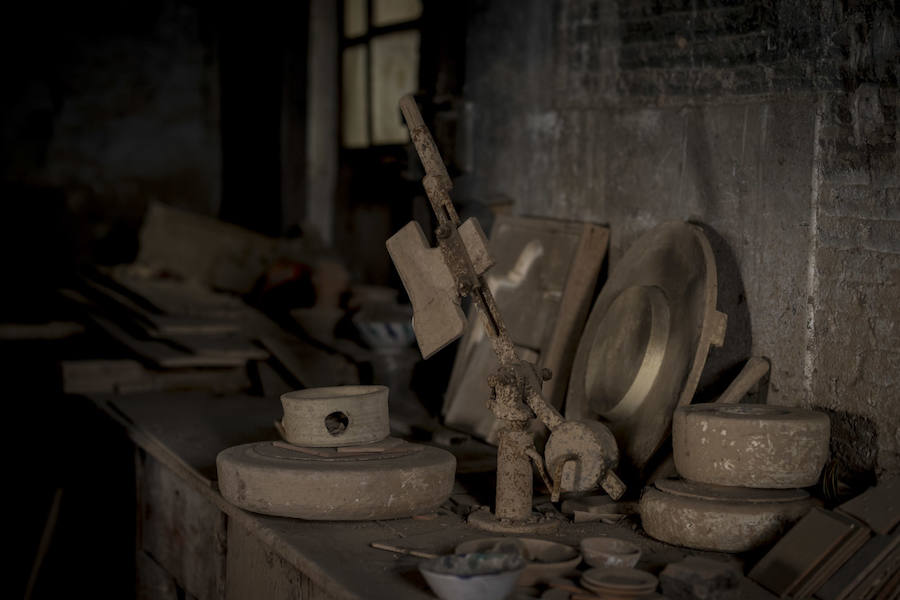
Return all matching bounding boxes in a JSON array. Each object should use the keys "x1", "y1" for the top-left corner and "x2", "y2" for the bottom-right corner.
[{"x1": 92, "y1": 393, "x2": 776, "y2": 599}]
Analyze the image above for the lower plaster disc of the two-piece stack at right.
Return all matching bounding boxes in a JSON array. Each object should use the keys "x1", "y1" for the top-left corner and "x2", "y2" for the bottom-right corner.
[{"x1": 640, "y1": 481, "x2": 813, "y2": 552}]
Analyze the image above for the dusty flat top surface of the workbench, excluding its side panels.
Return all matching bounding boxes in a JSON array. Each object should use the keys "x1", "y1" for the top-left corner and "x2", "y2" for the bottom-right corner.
[{"x1": 92, "y1": 393, "x2": 768, "y2": 599}]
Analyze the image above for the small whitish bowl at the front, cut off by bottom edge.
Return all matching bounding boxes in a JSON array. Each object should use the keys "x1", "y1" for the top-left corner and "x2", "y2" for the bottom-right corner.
[{"x1": 419, "y1": 552, "x2": 525, "y2": 600}]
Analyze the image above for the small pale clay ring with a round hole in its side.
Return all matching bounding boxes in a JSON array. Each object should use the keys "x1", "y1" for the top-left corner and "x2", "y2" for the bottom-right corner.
[{"x1": 281, "y1": 385, "x2": 390, "y2": 448}]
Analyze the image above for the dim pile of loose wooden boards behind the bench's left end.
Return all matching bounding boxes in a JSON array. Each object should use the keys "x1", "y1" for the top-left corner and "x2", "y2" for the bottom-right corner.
[{"x1": 63, "y1": 267, "x2": 358, "y2": 393}]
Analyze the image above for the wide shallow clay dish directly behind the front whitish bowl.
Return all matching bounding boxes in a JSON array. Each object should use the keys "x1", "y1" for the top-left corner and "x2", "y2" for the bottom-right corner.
[{"x1": 456, "y1": 537, "x2": 581, "y2": 585}]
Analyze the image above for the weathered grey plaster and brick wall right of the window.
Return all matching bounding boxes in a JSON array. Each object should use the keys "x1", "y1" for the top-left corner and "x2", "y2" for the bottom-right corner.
[{"x1": 466, "y1": 0, "x2": 900, "y2": 473}]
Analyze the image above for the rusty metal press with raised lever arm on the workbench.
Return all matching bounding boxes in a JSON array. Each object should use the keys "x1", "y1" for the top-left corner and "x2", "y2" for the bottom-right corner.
[{"x1": 387, "y1": 96, "x2": 625, "y2": 531}]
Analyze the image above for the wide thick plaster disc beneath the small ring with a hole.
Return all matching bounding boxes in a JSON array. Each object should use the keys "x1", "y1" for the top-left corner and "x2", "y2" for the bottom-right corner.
[{"x1": 216, "y1": 440, "x2": 456, "y2": 521}]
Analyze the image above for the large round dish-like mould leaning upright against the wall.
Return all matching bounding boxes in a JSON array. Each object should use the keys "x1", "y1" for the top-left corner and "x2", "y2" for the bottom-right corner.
[{"x1": 566, "y1": 221, "x2": 725, "y2": 470}]
